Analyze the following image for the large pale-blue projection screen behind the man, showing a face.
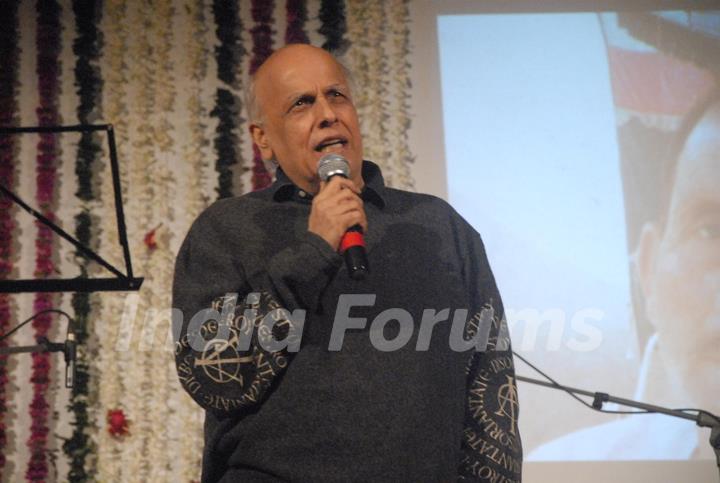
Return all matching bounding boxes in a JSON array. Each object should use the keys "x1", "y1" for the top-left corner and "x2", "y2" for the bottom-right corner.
[{"x1": 408, "y1": 2, "x2": 720, "y2": 481}]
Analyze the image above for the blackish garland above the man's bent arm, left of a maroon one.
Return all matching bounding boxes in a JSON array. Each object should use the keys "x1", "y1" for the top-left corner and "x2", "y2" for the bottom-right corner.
[{"x1": 210, "y1": 0, "x2": 244, "y2": 198}]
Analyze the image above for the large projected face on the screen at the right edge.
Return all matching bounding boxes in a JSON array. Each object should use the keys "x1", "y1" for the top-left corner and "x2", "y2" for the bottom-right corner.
[{"x1": 639, "y1": 101, "x2": 720, "y2": 413}]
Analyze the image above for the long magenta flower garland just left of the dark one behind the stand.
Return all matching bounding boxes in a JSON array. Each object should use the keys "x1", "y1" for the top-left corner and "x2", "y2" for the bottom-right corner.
[{"x1": 25, "y1": 0, "x2": 60, "y2": 481}]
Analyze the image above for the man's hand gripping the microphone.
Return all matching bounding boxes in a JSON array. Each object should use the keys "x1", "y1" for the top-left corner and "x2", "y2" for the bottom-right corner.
[{"x1": 308, "y1": 176, "x2": 367, "y2": 250}]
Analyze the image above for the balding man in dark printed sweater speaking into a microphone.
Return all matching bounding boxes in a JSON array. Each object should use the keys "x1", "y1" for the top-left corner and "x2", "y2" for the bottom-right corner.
[{"x1": 173, "y1": 44, "x2": 522, "y2": 482}]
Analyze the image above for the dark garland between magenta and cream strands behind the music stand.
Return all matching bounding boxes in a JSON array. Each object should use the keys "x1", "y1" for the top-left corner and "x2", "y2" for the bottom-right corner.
[{"x1": 63, "y1": 0, "x2": 102, "y2": 481}]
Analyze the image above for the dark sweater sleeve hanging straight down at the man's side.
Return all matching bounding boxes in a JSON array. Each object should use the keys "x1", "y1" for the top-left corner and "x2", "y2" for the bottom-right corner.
[{"x1": 458, "y1": 216, "x2": 522, "y2": 482}]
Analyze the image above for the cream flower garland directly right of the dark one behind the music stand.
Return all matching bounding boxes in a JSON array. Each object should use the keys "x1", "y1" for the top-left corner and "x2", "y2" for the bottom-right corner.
[{"x1": 91, "y1": 0, "x2": 130, "y2": 481}]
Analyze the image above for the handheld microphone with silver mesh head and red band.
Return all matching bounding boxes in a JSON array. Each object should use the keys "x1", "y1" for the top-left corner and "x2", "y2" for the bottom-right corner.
[{"x1": 318, "y1": 153, "x2": 370, "y2": 280}]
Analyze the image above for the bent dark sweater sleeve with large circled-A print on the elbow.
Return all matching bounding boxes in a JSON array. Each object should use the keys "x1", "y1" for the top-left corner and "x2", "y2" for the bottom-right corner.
[{"x1": 173, "y1": 204, "x2": 341, "y2": 416}]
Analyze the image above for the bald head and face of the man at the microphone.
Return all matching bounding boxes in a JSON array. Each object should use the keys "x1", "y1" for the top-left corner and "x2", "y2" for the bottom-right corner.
[{"x1": 250, "y1": 45, "x2": 363, "y2": 193}]
